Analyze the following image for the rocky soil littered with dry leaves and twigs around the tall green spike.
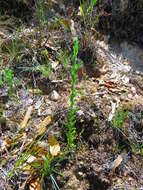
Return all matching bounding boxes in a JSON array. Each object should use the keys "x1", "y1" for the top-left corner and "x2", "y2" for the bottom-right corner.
[{"x1": 0, "y1": 0, "x2": 143, "y2": 190}]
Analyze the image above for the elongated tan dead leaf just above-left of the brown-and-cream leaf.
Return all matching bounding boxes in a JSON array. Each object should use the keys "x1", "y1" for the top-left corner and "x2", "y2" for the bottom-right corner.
[{"x1": 37, "y1": 116, "x2": 52, "y2": 135}]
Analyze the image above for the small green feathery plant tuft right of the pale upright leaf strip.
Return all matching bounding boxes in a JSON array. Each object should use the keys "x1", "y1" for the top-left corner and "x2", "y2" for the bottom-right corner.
[{"x1": 113, "y1": 106, "x2": 128, "y2": 129}]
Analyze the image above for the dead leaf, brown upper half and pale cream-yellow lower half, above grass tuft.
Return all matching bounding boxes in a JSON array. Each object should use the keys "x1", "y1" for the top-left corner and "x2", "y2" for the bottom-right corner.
[{"x1": 48, "y1": 136, "x2": 60, "y2": 156}]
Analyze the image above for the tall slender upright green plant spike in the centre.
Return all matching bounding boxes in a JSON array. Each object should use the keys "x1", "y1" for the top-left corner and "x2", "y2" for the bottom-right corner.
[{"x1": 66, "y1": 37, "x2": 81, "y2": 147}]
